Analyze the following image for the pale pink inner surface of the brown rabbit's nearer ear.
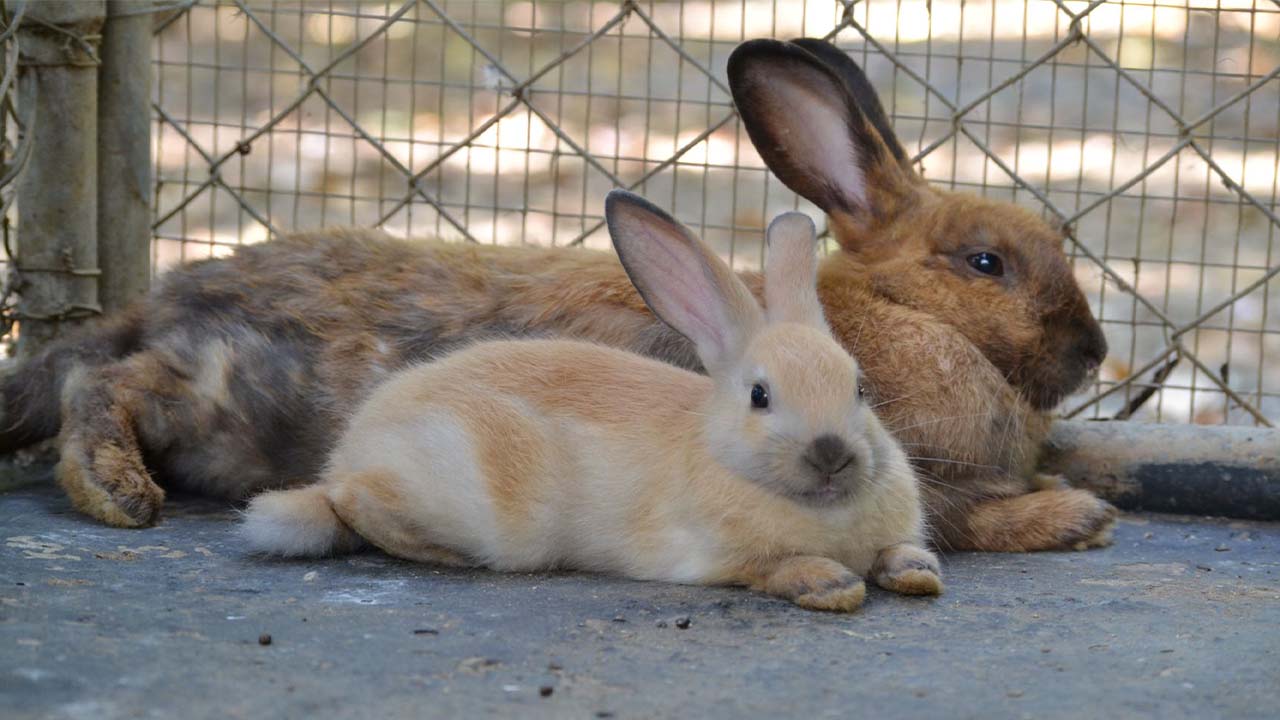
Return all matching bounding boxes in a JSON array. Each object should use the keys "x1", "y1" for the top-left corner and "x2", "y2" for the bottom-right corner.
[{"x1": 771, "y1": 82, "x2": 867, "y2": 208}]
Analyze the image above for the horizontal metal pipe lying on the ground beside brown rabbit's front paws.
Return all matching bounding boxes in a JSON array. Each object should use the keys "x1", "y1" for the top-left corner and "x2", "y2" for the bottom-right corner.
[{"x1": 1041, "y1": 420, "x2": 1280, "y2": 520}]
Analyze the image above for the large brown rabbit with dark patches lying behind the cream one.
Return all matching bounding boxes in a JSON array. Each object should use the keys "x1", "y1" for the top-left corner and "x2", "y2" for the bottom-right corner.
[{"x1": 0, "y1": 40, "x2": 1114, "y2": 551}]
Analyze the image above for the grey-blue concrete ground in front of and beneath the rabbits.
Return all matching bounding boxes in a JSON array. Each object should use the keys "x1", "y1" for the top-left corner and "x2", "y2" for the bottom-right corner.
[{"x1": 0, "y1": 483, "x2": 1280, "y2": 720}]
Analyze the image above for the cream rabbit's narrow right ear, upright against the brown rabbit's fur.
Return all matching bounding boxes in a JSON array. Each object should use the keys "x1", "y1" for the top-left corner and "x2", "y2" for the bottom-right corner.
[{"x1": 764, "y1": 213, "x2": 828, "y2": 331}]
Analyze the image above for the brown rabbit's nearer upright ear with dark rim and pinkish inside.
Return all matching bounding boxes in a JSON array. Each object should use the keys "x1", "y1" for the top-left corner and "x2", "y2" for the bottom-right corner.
[{"x1": 728, "y1": 40, "x2": 918, "y2": 250}]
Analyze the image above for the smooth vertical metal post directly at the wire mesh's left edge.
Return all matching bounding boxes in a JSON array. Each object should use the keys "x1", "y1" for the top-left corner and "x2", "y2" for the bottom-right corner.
[{"x1": 97, "y1": 0, "x2": 152, "y2": 314}]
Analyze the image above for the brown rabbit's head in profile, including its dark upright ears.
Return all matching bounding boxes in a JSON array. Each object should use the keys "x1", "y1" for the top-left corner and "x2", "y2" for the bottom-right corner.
[{"x1": 728, "y1": 38, "x2": 1107, "y2": 409}]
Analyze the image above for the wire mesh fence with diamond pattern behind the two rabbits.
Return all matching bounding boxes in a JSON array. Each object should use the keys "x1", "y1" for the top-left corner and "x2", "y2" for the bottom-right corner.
[{"x1": 5, "y1": 0, "x2": 1280, "y2": 425}]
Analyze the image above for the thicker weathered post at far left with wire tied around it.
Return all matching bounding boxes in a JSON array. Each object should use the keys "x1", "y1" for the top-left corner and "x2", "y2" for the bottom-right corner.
[{"x1": 15, "y1": 0, "x2": 105, "y2": 359}]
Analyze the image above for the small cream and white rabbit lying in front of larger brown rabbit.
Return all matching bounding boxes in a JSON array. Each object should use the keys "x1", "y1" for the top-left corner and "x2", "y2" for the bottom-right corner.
[{"x1": 243, "y1": 191, "x2": 942, "y2": 611}]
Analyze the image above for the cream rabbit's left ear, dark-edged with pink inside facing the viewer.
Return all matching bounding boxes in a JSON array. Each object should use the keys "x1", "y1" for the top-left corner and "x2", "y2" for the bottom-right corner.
[{"x1": 604, "y1": 190, "x2": 764, "y2": 374}]
